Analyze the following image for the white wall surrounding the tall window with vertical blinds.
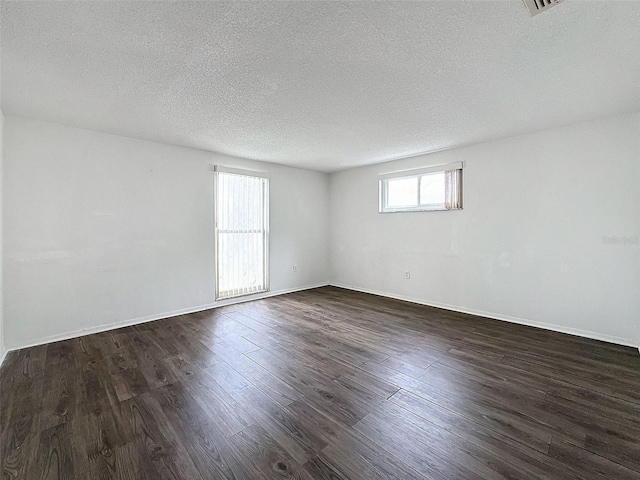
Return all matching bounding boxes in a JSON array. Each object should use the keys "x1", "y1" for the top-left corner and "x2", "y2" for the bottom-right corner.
[{"x1": 4, "y1": 116, "x2": 329, "y2": 348}]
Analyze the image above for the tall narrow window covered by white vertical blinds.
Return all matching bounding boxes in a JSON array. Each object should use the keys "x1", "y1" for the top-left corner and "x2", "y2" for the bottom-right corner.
[{"x1": 214, "y1": 165, "x2": 269, "y2": 300}]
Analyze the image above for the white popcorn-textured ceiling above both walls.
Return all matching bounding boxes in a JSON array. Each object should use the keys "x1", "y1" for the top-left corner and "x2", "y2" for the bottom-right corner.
[{"x1": 2, "y1": 0, "x2": 640, "y2": 171}]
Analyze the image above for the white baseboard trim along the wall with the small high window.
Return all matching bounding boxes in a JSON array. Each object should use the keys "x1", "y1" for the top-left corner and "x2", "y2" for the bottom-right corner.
[{"x1": 329, "y1": 282, "x2": 640, "y2": 352}]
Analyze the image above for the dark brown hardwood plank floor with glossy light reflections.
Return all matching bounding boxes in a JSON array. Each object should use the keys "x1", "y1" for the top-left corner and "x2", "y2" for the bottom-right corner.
[{"x1": 0, "y1": 287, "x2": 640, "y2": 479}]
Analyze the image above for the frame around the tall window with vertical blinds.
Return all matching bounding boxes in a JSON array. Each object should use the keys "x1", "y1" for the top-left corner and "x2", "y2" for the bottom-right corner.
[{"x1": 212, "y1": 165, "x2": 270, "y2": 301}]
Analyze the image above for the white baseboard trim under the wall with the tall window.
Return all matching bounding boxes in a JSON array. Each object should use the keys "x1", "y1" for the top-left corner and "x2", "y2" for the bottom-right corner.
[{"x1": 6, "y1": 282, "x2": 329, "y2": 352}]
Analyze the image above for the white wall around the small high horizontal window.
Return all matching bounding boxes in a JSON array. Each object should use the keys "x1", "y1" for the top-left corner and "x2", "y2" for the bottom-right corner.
[{"x1": 330, "y1": 114, "x2": 640, "y2": 346}]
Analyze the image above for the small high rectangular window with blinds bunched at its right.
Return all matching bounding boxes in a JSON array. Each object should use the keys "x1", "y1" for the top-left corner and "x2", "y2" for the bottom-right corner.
[{"x1": 379, "y1": 162, "x2": 462, "y2": 213}]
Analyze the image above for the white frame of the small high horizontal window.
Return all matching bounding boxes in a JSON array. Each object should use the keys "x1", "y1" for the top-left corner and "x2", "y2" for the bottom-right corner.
[{"x1": 378, "y1": 162, "x2": 462, "y2": 213}]
